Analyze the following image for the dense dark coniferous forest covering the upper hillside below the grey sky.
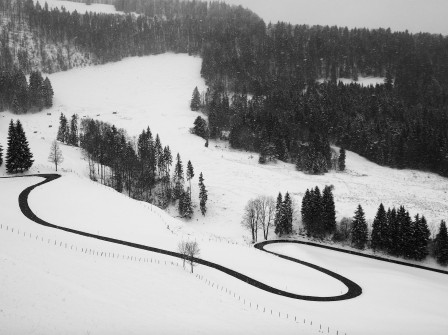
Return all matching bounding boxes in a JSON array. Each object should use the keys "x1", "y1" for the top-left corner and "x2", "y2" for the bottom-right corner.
[{"x1": 0, "y1": 0, "x2": 448, "y2": 176}]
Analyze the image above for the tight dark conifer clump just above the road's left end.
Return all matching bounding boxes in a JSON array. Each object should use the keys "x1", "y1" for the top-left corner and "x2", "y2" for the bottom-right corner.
[{"x1": 0, "y1": 120, "x2": 34, "y2": 173}]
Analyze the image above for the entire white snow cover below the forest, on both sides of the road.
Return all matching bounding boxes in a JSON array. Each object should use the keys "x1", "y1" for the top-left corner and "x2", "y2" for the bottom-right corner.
[{"x1": 0, "y1": 54, "x2": 448, "y2": 334}]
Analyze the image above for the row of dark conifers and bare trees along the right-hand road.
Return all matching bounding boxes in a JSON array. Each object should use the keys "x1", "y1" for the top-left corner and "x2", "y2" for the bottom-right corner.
[{"x1": 241, "y1": 186, "x2": 448, "y2": 266}]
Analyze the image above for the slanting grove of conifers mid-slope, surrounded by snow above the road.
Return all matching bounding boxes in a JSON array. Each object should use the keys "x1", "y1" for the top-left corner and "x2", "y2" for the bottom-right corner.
[{"x1": 79, "y1": 118, "x2": 208, "y2": 218}]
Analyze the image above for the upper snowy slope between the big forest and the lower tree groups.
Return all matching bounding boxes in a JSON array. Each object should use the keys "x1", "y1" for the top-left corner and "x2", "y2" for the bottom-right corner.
[{"x1": 0, "y1": 54, "x2": 448, "y2": 239}]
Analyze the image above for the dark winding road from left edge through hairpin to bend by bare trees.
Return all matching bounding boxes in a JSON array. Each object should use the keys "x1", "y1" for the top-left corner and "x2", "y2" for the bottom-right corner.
[{"x1": 2, "y1": 174, "x2": 362, "y2": 301}]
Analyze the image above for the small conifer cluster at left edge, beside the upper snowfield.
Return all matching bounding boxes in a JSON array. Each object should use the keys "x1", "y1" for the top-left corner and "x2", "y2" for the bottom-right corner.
[{"x1": 0, "y1": 66, "x2": 54, "y2": 114}]
